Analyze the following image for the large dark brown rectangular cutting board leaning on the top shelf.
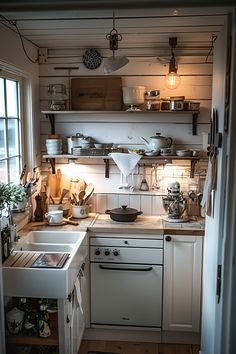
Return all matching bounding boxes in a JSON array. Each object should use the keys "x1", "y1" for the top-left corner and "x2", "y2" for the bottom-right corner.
[{"x1": 71, "y1": 77, "x2": 122, "y2": 111}]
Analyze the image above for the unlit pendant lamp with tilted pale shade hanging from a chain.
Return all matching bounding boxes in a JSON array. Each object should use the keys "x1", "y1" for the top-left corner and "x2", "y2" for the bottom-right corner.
[{"x1": 103, "y1": 11, "x2": 129, "y2": 74}]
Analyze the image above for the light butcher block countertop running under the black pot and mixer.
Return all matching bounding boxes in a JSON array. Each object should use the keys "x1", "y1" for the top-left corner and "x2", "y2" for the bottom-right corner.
[{"x1": 18, "y1": 213, "x2": 205, "y2": 237}]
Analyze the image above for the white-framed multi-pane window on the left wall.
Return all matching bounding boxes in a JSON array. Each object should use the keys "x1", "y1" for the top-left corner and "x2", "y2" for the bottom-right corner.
[{"x1": 0, "y1": 76, "x2": 22, "y2": 182}]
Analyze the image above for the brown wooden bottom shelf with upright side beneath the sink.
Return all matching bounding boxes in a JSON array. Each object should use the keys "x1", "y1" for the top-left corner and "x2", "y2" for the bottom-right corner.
[{"x1": 6, "y1": 313, "x2": 59, "y2": 346}]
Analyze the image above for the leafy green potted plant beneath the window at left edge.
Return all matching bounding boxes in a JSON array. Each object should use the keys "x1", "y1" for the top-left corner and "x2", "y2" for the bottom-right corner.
[{"x1": 0, "y1": 182, "x2": 26, "y2": 216}]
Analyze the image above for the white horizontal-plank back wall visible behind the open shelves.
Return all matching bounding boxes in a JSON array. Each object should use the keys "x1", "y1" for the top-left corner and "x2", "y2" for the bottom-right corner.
[{"x1": 40, "y1": 57, "x2": 212, "y2": 215}]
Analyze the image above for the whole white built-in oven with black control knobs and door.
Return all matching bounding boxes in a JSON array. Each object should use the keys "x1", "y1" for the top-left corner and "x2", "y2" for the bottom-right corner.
[{"x1": 90, "y1": 234, "x2": 163, "y2": 328}]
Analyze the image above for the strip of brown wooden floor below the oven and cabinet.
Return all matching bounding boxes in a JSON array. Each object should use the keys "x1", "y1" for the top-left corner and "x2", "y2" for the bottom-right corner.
[{"x1": 78, "y1": 340, "x2": 200, "y2": 354}]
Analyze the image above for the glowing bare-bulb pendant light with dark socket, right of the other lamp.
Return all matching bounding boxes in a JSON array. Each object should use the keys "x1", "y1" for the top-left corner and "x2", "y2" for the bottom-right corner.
[{"x1": 165, "y1": 37, "x2": 181, "y2": 90}]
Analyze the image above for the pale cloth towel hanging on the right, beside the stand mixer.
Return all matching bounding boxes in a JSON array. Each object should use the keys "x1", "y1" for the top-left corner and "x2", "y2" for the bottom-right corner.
[{"x1": 201, "y1": 154, "x2": 217, "y2": 216}]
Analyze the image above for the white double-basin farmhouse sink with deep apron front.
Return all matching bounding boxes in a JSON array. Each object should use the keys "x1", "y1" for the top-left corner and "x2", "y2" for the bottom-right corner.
[{"x1": 3, "y1": 230, "x2": 88, "y2": 299}]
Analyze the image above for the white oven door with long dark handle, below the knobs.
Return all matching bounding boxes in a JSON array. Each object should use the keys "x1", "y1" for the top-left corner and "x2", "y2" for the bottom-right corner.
[{"x1": 91, "y1": 263, "x2": 162, "y2": 327}]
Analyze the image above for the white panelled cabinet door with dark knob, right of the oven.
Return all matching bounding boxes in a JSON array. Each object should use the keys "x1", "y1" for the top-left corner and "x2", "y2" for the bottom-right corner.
[{"x1": 163, "y1": 235, "x2": 202, "y2": 332}]
